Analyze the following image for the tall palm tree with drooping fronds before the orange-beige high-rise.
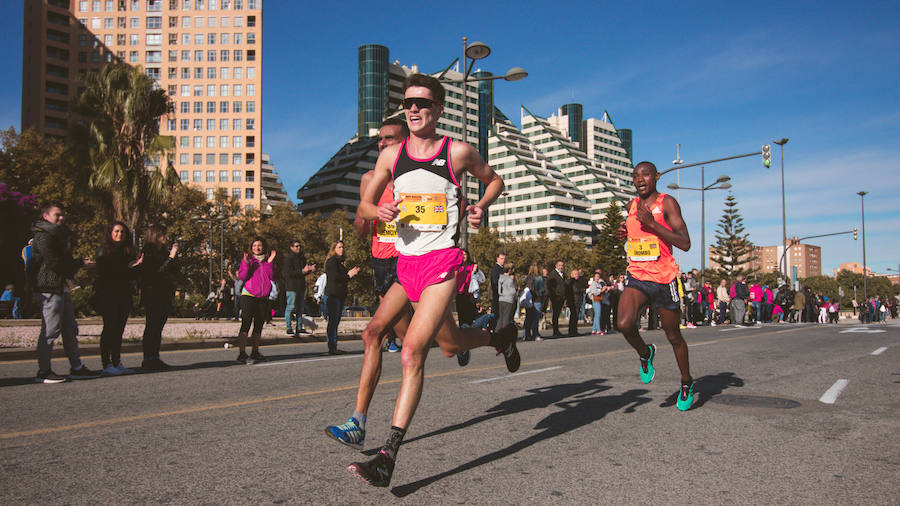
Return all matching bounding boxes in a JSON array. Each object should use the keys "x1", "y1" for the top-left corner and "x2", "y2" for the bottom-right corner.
[{"x1": 76, "y1": 63, "x2": 180, "y2": 230}]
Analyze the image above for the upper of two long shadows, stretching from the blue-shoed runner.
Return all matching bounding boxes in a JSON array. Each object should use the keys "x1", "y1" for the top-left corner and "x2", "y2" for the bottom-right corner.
[{"x1": 363, "y1": 378, "x2": 612, "y2": 455}]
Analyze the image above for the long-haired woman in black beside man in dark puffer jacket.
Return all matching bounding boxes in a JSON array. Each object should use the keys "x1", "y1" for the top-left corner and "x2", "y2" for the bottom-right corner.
[{"x1": 94, "y1": 221, "x2": 144, "y2": 376}]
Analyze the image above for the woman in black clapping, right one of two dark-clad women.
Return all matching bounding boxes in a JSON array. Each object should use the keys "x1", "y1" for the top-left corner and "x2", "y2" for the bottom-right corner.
[{"x1": 139, "y1": 225, "x2": 178, "y2": 371}]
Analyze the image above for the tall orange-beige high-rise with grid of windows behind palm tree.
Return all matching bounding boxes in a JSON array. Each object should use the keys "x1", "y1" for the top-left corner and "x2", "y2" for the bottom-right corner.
[{"x1": 22, "y1": 0, "x2": 263, "y2": 209}]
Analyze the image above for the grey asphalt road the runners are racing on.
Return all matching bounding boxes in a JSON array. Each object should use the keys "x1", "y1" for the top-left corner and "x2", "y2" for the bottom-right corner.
[{"x1": 0, "y1": 324, "x2": 900, "y2": 504}]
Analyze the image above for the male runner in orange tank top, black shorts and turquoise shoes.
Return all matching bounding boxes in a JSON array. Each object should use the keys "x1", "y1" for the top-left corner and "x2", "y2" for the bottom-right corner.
[{"x1": 618, "y1": 162, "x2": 694, "y2": 411}]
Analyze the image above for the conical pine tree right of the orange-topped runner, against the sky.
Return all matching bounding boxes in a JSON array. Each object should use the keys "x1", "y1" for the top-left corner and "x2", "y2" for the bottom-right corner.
[{"x1": 710, "y1": 192, "x2": 759, "y2": 279}]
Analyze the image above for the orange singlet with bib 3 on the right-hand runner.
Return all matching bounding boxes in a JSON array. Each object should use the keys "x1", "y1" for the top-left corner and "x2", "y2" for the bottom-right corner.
[{"x1": 625, "y1": 193, "x2": 678, "y2": 284}]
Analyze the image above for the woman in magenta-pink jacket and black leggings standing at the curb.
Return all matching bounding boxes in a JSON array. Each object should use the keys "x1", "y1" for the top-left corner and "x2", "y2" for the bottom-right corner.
[{"x1": 237, "y1": 237, "x2": 275, "y2": 364}]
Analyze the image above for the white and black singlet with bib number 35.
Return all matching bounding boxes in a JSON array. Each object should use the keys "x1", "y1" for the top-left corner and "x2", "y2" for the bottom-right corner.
[{"x1": 393, "y1": 137, "x2": 461, "y2": 256}]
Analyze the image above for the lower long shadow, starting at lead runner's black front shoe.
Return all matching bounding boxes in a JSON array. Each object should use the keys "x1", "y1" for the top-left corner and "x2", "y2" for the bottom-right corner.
[{"x1": 391, "y1": 386, "x2": 651, "y2": 497}]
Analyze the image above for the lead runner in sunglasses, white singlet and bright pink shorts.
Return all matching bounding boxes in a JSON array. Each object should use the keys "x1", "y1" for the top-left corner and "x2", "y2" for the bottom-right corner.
[{"x1": 348, "y1": 74, "x2": 521, "y2": 487}]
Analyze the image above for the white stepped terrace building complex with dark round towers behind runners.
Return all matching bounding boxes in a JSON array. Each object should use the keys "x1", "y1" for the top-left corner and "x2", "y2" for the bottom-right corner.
[{"x1": 297, "y1": 44, "x2": 633, "y2": 241}]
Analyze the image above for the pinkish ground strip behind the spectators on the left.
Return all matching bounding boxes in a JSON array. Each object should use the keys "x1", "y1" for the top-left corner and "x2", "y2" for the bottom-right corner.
[{"x1": 0, "y1": 317, "x2": 371, "y2": 362}]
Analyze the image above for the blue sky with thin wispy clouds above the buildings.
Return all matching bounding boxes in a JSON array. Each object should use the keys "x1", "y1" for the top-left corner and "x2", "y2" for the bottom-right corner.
[{"x1": 0, "y1": 0, "x2": 900, "y2": 274}]
